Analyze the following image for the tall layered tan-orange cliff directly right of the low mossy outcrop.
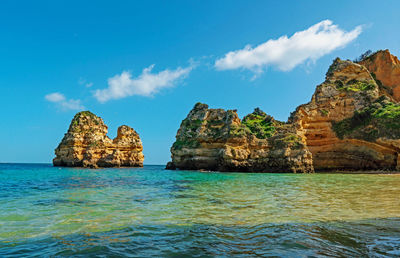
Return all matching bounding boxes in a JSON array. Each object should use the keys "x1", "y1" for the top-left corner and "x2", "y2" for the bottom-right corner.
[{"x1": 289, "y1": 59, "x2": 400, "y2": 171}]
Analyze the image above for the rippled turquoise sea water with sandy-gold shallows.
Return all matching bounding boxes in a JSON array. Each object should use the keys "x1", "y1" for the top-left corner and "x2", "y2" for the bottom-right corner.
[{"x1": 0, "y1": 164, "x2": 400, "y2": 257}]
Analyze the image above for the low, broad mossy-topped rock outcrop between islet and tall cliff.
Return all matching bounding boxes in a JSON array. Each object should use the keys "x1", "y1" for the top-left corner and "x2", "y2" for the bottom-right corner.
[{"x1": 167, "y1": 103, "x2": 313, "y2": 173}]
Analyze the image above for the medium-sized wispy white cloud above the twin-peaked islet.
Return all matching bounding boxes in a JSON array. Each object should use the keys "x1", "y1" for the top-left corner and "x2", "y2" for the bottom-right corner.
[{"x1": 94, "y1": 65, "x2": 193, "y2": 103}]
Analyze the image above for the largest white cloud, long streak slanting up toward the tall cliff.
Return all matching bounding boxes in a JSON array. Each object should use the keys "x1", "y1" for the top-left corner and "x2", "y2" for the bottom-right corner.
[{"x1": 215, "y1": 20, "x2": 362, "y2": 73}]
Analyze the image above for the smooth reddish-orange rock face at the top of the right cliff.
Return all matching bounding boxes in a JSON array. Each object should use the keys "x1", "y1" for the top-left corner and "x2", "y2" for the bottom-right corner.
[{"x1": 359, "y1": 50, "x2": 400, "y2": 102}]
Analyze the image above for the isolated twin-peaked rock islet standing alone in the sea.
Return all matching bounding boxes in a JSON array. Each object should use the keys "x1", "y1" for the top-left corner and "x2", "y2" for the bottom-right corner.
[{"x1": 53, "y1": 111, "x2": 144, "y2": 168}]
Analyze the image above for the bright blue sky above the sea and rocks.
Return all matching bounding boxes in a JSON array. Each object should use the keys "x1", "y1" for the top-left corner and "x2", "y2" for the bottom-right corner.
[{"x1": 0, "y1": 0, "x2": 400, "y2": 164}]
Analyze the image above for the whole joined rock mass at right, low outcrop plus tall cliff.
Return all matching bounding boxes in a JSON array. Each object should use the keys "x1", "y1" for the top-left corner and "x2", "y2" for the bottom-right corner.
[{"x1": 167, "y1": 50, "x2": 400, "y2": 173}]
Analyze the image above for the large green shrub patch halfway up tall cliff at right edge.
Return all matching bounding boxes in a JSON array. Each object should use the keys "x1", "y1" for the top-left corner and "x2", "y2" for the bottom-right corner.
[{"x1": 332, "y1": 96, "x2": 400, "y2": 141}]
